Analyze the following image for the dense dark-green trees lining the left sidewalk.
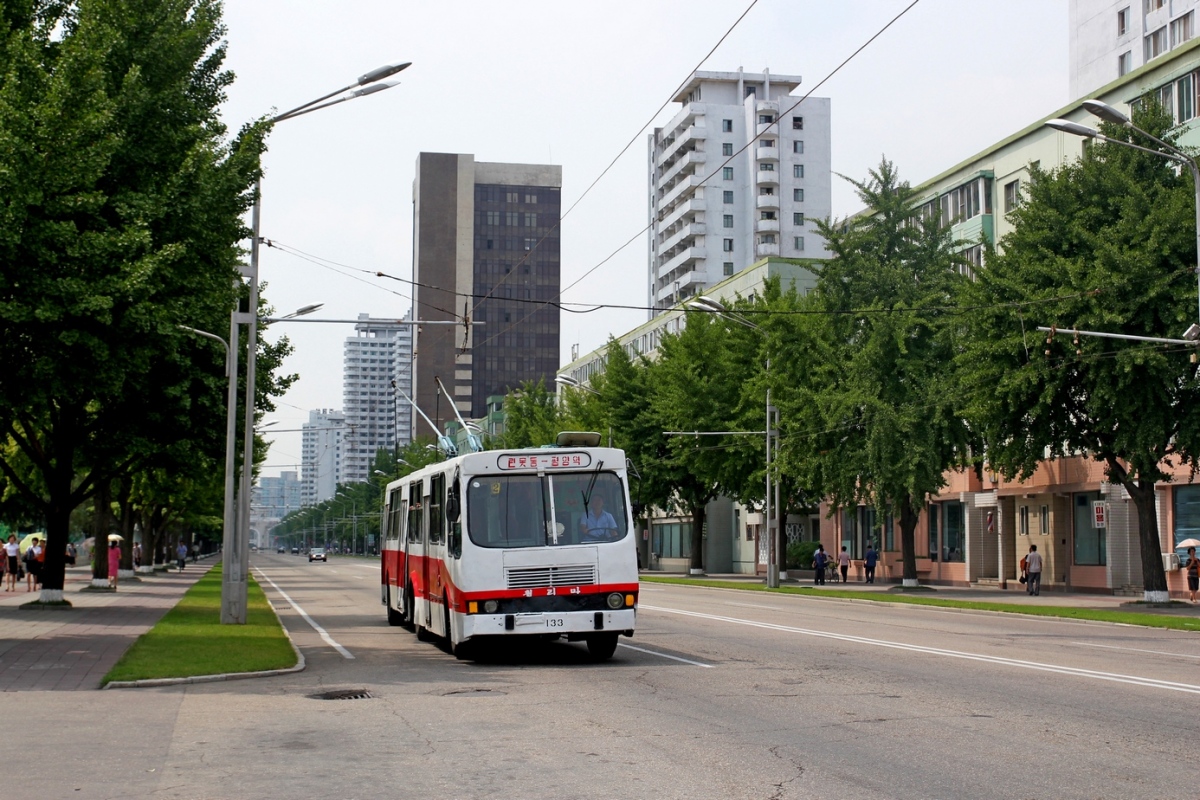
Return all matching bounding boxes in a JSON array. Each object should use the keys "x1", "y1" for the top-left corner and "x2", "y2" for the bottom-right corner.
[{"x1": 0, "y1": 0, "x2": 294, "y2": 599}]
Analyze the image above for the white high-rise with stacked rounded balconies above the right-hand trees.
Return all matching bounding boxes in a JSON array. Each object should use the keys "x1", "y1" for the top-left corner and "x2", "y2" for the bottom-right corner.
[{"x1": 647, "y1": 68, "x2": 833, "y2": 317}]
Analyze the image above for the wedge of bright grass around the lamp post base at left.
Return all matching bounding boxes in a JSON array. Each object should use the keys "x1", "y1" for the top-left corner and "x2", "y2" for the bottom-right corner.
[{"x1": 103, "y1": 564, "x2": 296, "y2": 684}]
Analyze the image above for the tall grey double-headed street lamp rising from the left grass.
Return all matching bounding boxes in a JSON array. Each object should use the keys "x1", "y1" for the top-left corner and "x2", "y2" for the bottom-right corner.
[{"x1": 221, "y1": 61, "x2": 410, "y2": 625}]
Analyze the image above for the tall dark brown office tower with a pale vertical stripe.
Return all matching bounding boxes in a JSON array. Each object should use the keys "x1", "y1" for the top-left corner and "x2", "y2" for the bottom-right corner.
[{"x1": 413, "y1": 152, "x2": 563, "y2": 435}]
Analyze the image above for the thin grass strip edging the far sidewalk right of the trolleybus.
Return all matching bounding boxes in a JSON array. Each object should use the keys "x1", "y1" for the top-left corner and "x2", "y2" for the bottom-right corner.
[{"x1": 641, "y1": 576, "x2": 1200, "y2": 631}]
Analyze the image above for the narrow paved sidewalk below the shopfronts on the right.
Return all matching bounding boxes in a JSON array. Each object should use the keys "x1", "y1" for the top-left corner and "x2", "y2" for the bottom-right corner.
[{"x1": 640, "y1": 570, "x2": 1200, "y2": 616}]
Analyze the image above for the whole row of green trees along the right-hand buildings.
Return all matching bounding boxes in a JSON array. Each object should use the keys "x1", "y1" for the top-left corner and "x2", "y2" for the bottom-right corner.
[{"x1": 497, "y1": 108, "x2": 1200, "y2": 599}]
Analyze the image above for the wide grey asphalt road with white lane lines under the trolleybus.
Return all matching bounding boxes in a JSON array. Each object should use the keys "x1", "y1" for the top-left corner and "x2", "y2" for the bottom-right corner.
[{"x1": 16, "y1": 554, "x2": 1200, "y2": 800}]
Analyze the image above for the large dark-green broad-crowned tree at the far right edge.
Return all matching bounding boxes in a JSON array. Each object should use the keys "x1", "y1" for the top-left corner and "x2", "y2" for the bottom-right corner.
[{"x1": 962, "y1": 108, "x2": 1200, "y2": 601}]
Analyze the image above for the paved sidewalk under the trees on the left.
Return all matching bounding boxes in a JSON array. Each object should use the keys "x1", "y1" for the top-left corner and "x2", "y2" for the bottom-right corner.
[{"x1": 0, "y1": 559, "x2": 215, "y2": 692}]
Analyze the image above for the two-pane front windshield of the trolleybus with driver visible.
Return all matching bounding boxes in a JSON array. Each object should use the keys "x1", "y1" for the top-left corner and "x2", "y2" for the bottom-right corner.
[{"x1": 467, "y1": 473, "x2": 629, "y2": 547}]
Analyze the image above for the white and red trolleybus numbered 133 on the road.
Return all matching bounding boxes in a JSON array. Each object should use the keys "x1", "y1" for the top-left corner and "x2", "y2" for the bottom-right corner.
[{"x1": 382, "y1": 433, "x2": 637, "y2": 660}]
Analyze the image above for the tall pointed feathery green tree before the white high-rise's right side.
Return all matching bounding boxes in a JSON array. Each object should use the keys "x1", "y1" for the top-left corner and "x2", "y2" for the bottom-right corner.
[{"x1": 779, "y1": 160, "x2": 972, "y2": 585}]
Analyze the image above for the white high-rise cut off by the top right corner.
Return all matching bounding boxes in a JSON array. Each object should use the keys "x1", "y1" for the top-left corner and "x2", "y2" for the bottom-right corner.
[{"x1": 1069, "y1": 0, "x2": 1200, "y2": 98}]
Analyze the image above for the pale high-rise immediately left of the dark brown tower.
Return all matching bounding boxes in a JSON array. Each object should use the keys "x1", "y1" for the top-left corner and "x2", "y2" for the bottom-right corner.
[{"x1": 340, "y1": 314, "x2": 413, "y2": 483}]
